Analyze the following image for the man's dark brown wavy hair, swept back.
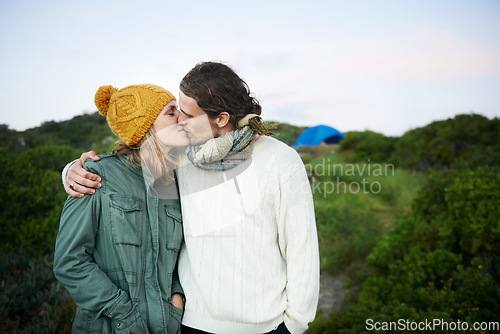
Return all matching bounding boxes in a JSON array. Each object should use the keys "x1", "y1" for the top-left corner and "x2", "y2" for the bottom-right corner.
[{"x1": 180, "y1": 62, "x2": 262, "y2": 124}]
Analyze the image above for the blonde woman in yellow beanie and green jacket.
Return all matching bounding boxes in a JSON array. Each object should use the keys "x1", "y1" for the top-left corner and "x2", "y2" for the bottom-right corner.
[{"x1": 54, "y1": 84, "x2": 189, "y2": 333}]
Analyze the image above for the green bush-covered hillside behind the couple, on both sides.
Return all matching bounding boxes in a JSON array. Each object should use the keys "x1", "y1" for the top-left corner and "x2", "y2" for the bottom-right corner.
[{"x1": 0, "y1": 113, "x2": 500, "y2": 333}]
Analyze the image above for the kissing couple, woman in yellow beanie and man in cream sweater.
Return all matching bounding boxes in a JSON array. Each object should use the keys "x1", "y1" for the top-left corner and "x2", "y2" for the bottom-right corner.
[{"x1": 54, "y1": 62, "x2": 319, "y2": 334}]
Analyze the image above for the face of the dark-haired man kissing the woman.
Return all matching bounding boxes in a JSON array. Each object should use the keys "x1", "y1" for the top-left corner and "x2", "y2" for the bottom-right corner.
[{"x1": 179, "y1": 92, "x2": 217, "y2": 144}]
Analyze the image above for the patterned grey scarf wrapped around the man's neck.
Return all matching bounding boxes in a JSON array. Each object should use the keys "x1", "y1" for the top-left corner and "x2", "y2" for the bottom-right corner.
[{"x1": 186, "y1": 126, "x2": 255, "y2": 170}]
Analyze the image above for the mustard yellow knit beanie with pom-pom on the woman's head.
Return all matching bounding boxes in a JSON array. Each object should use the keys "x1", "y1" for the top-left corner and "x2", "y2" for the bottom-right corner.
[{"x1": 94, "y1": 84, "x2": 175, "y2": 146}]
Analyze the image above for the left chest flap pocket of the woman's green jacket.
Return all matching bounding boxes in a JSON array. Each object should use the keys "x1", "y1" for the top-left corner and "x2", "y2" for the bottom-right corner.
[{"x1": 110, "y1": 194, "x2": 145, "y2": 247}]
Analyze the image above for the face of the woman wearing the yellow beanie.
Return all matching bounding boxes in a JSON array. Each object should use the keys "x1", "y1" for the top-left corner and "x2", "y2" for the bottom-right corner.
[{"x1": 153, "y1": 100, "x2": 189, "y2": 147}]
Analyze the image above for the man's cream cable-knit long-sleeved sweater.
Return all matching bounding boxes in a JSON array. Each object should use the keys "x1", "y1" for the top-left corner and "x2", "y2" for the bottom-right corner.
[{"x1": 178, "y1": 137, "x2": 319, "y2": 334}]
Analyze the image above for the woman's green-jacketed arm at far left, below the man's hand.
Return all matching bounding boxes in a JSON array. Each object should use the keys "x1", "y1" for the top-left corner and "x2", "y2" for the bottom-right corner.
[{"x1": 54, "y1": 162, "x2": 133, "y2": 320}]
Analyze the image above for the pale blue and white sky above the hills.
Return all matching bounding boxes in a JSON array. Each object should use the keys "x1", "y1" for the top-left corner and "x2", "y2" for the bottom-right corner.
[{"x1": 0, "y1": 0, "x2": 500, "y2": 136}]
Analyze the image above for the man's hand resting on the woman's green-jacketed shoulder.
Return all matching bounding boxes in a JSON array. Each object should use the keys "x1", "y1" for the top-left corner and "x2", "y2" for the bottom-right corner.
[{"x1": 64, "y1": 151, "x2": 101, "y2": 197}]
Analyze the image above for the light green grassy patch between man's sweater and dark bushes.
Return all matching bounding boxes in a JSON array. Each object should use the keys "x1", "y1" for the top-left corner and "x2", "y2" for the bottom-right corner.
[{"x1": 306, "y1": 154, "x2": 424, "y2": 274}]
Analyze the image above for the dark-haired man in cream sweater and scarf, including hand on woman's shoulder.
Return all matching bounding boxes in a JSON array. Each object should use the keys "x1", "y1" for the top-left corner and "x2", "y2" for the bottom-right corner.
[{"x1": 65, "y1": 62, "x2": 319, "y2": 334}]
